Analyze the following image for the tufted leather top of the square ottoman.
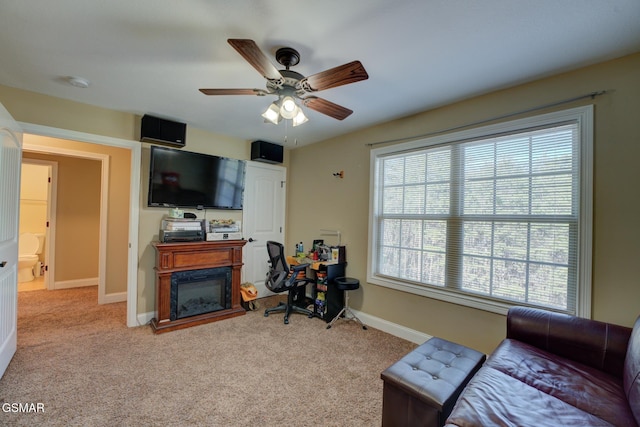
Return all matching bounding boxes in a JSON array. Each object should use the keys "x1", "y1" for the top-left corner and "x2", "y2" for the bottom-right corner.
[{"x1": 381, "y1": 337, "x2": 486, "y2": 413}]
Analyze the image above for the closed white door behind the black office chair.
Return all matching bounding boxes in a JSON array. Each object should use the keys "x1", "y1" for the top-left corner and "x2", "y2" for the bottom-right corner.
[{"x1": 242, "y1": 162, "x2": 286, "y2": 298}]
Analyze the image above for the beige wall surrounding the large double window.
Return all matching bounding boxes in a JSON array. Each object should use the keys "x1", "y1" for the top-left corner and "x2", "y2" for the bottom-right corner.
[{"x1": 287, "y1": 54, "x2": 640, "y2": 352}]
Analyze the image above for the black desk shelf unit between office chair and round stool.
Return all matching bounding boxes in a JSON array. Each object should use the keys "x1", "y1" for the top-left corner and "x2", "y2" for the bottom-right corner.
[{"x1": 313, "y1": 263, "x2": 346, "y2": 323}]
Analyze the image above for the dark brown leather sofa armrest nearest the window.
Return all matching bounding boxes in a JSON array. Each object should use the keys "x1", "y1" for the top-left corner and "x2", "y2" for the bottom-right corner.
[{"x1": 507, "y1": 307, "x2": 631, "y2": 378}]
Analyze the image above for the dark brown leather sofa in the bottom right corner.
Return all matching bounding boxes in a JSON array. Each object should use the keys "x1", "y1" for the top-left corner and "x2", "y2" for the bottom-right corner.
[{"x1": 446, "y1": 307, "x2": 640, "y2": 427}]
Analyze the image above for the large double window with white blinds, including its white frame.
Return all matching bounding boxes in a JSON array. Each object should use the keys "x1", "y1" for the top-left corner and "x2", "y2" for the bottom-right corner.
[{"x1": 368, "y1": 107, "x2": 593, "y2": 317}]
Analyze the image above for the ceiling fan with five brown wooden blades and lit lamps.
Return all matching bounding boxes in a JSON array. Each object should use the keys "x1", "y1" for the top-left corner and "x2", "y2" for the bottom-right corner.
[{"x1": 200, "y1": 39, "x2": 369, "y2": 126}]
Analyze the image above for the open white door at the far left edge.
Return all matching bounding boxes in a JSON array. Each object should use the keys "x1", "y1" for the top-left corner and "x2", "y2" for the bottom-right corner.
[{"x1": 0, "y1": 104, "x2": 22, "y2": 377}]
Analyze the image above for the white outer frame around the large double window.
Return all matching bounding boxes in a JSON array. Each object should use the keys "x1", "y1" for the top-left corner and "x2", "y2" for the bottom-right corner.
[{"x1": 367, "y1": 105, "x2": 594, "y2": 318}]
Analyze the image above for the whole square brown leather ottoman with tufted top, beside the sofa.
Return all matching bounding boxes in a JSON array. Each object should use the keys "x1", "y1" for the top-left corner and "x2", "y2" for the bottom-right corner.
[{"x1": 380, "y1": 337, "x2": 486, "y2": 427}]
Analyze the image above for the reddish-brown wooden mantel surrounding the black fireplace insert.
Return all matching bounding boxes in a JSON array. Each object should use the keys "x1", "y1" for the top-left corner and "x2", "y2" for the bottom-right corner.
[{"x1": 151, "y1": 240, "x2": 247, "y2": 333}]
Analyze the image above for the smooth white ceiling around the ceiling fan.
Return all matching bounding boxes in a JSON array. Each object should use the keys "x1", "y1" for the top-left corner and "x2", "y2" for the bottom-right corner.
[{"x1": 0, "y1": 0, "x2": 640, "y2": 148}]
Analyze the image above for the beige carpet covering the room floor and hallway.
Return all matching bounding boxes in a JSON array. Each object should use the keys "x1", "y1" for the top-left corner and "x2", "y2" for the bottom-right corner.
[{"x1": 0, "y1": 287, "x2": 415, "y2": 426}]
